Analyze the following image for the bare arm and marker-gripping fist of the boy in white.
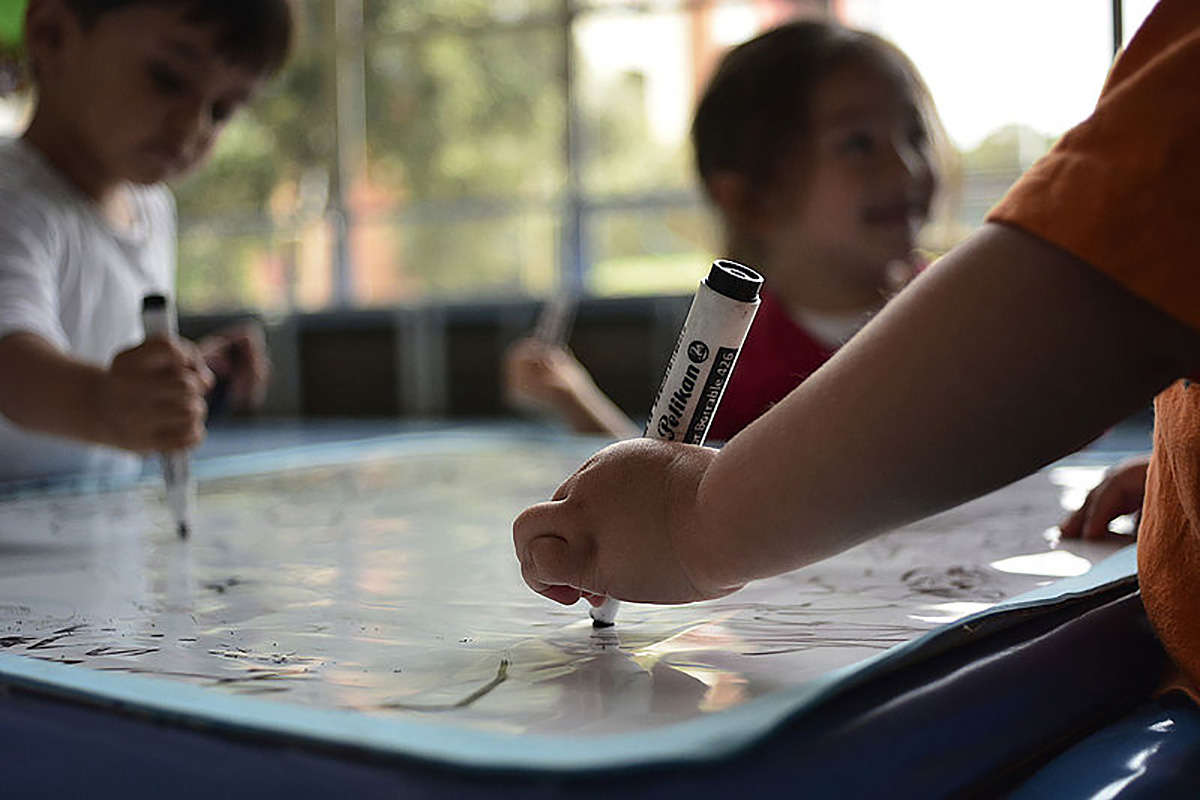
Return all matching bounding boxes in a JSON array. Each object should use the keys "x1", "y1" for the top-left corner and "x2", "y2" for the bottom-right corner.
[{"x1": 0, "y1": 332, "x2": 211, "y2": 452}]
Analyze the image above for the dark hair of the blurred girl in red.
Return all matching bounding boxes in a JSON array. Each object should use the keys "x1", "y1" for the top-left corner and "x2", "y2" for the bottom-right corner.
[{"x1": 691, "y1": 19, "x2": 944, "y2": 193}]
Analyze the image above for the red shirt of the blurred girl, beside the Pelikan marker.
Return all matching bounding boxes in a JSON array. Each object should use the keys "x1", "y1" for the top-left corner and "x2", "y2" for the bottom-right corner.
[{"x1": 708, "y1": 290, "x2": 834, "y2": 439}]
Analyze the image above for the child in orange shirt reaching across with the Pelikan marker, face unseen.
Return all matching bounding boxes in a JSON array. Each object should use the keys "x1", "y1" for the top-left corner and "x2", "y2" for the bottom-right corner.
[{"x1": 514, "y1": 0, "x2": 1200, "y2": 697}]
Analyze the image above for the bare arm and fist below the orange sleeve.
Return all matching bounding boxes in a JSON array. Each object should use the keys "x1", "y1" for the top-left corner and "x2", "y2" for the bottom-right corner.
[{"x1": 514, "y1": 224, "x2": 1200, "y2": 602}]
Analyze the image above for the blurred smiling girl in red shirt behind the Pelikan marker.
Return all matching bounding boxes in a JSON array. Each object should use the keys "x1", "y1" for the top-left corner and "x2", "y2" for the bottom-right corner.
[{"x1": 506, "y1": 20, "x2": 946, "y2": 439}]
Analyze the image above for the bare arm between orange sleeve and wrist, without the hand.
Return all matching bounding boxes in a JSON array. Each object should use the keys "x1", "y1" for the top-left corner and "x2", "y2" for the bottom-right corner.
[{"x1": 694, "y1": 225, "x2": 1200, "y2": 585}]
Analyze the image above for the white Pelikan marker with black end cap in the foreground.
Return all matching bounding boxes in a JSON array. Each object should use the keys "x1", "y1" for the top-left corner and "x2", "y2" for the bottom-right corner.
[{"x1": 592, "y1": 259, "x2": 762, "y2": 627}]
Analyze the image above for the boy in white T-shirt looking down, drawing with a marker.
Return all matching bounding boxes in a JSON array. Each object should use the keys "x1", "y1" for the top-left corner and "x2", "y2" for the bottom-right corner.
[{"x1": 0, "y1": 0, "x2": 292, "y2": 480}]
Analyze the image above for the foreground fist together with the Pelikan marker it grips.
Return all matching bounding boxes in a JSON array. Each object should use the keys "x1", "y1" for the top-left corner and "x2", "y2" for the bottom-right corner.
[{"x1": 512, "y1": 260, "x2": 763, "y2": 627}]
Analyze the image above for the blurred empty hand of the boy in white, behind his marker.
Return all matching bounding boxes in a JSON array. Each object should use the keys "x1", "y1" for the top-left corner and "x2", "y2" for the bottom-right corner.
[{"x1": 199, "y1": 321, "x2": 271, "y2": 414}]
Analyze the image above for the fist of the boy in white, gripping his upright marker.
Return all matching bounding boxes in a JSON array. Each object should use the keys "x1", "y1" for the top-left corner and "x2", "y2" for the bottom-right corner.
[{"x1": 100, "y1": 338, "x2": 212, "y2": 452}]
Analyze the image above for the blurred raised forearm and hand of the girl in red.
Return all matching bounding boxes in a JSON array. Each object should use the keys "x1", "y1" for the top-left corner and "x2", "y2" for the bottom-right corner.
[{"x1": 504, "y1": 338, "x2": 641, "y2": 439}]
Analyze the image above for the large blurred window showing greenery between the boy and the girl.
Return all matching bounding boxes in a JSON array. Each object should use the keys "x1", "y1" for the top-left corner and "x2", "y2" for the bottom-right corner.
[{"x1": 179, "y1": 0, "x2": 844, "y2": 311}]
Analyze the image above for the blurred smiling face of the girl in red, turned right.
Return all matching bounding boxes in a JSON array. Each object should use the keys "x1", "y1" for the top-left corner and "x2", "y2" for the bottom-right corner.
[{"x1": 763, "y1": 58, "x2": 937, "y2": 303}]
